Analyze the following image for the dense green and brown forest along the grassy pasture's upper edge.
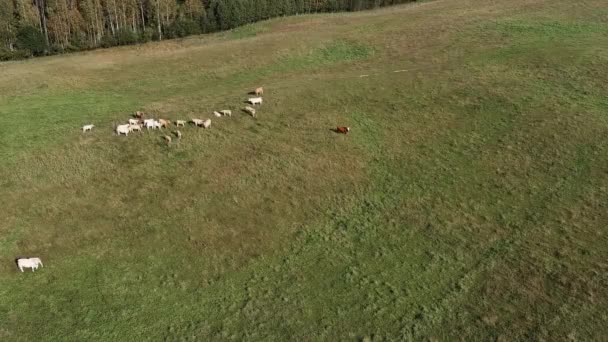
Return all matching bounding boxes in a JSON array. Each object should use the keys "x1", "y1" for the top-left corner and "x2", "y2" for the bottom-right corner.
[{"x1": 0, "y1": 0, "x2": 415, "y2": 60}]
